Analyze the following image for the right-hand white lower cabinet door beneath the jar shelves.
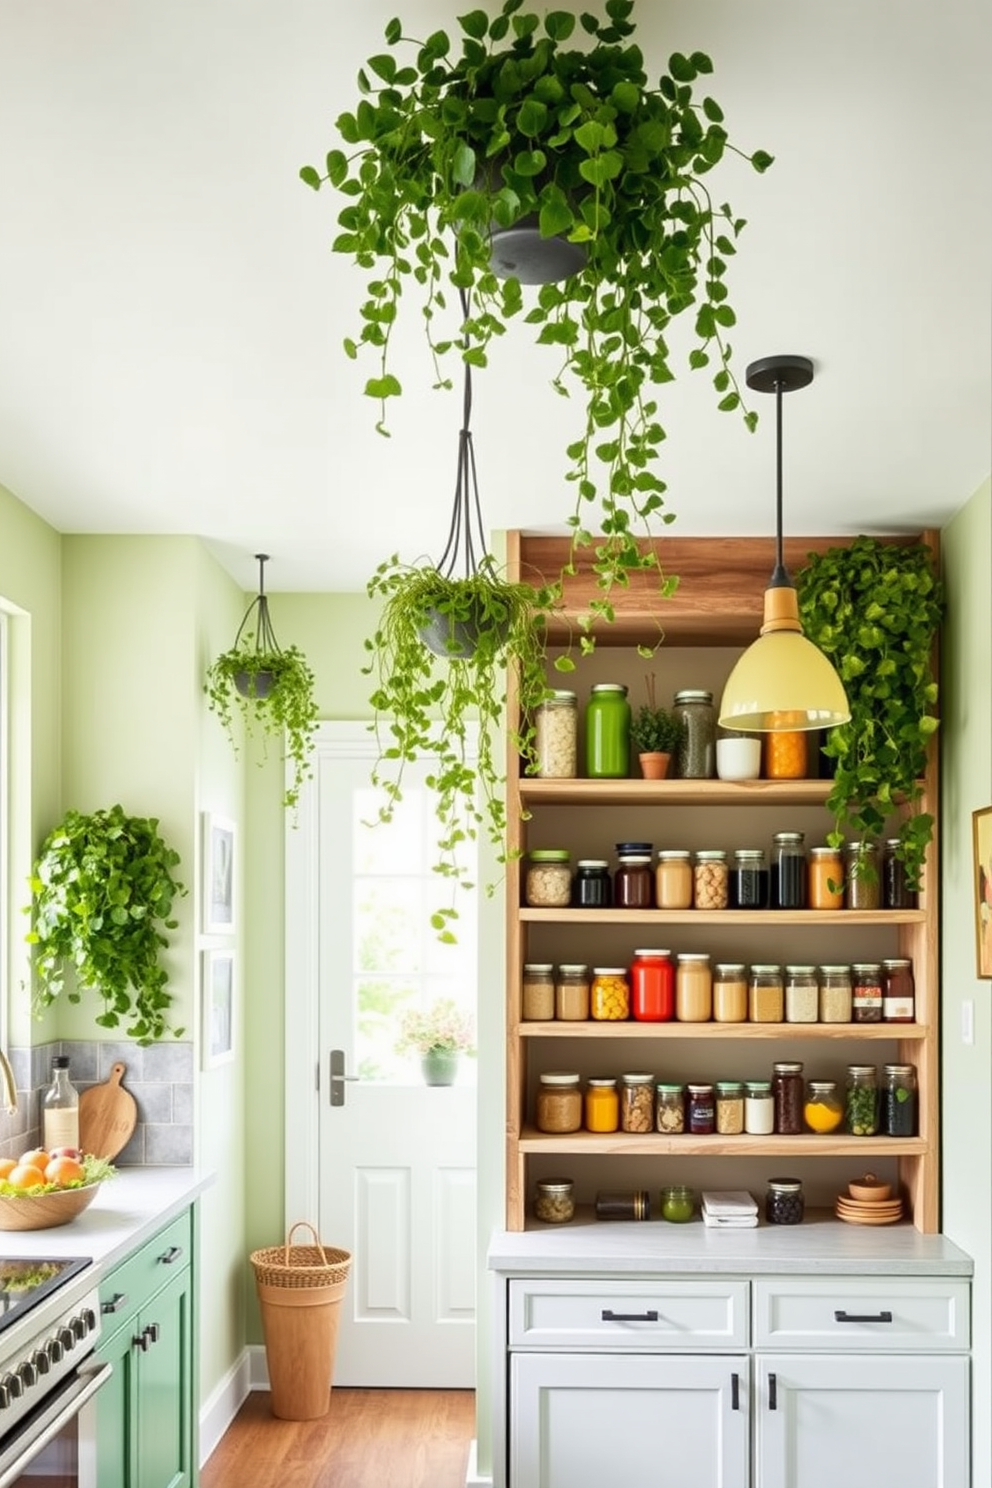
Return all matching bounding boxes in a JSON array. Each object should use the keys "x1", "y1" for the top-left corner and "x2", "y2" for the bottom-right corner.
[{"x1": 756, "y1": 1354, "x2": 970, "y2": 1488}]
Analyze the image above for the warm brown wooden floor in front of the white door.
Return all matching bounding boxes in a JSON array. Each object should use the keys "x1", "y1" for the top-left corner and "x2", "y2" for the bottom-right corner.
[{"x1": 199, "y1": 1387, "x2": 476, "y2": 1488}]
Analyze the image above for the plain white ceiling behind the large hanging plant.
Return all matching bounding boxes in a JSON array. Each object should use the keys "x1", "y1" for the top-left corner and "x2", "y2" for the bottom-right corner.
[{"x1": 0, "y1": 0, "x2": 992, "y2": 591}]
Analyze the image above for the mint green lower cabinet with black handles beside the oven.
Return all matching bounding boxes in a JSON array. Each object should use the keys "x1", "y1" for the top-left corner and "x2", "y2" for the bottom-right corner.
[{"x1": 97, "y1": 1211, "x2": 196, "y2": 1488}]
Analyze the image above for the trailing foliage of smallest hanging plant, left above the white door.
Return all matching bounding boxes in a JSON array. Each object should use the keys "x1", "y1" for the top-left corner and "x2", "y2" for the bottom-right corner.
[{"x1": 204, "y1": 631, "x2": 317, "y2": 806}]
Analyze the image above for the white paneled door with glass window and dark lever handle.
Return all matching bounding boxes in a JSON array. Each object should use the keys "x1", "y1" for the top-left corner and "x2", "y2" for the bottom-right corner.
[{"x1": 287, "y1": 723, "x2": 477, "y2": 1388}]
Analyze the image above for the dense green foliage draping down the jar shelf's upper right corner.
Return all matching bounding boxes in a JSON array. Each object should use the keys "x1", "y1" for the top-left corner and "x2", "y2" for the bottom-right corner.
[{"x1": 796, "y1": 537, "x2": 943, "y2": 887}]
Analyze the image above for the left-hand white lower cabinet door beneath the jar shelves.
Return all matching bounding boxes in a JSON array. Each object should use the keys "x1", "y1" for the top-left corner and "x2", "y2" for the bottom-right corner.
[{"x1": 509, "y1": 1354, "x2": 743, "y2": 1488}]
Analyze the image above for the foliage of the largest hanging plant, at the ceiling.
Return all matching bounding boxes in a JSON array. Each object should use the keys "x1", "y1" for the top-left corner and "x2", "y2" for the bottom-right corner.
[{"x1": 300, "y1": 0, "x2": 772, "y2": 633}]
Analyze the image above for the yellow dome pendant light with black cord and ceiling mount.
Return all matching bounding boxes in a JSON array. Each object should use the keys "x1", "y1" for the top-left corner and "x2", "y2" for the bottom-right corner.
[{"x1": 720, "y1": 356, "x2": 851, "y2": 734}]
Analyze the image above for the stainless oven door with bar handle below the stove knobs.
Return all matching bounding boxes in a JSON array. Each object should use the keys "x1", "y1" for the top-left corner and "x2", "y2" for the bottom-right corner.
[{"x1": 0, "y1": 1359, "x2": 113, "y2": 1488}]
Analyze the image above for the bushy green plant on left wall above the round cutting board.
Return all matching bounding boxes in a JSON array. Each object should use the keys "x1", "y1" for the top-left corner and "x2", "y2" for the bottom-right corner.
[{"x1": 27, "y1": 805, "x2": 186, "y2": 1045}]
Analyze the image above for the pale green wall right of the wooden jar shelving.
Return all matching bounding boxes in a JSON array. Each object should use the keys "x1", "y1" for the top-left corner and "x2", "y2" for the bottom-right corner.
[{"x1": 940, "y1": 481, "x2": 992, "y2": 1484}]
